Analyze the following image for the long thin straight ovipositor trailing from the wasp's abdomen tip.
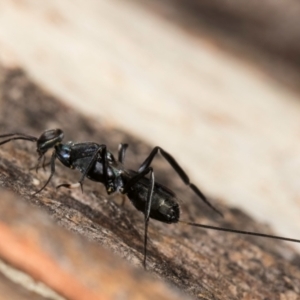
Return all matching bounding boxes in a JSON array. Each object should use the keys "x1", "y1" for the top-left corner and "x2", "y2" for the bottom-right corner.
[{"x1": 179, "y1": 221, "x2": 300, "y2": 243}]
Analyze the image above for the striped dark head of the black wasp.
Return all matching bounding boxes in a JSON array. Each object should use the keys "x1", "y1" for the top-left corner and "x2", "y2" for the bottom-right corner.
[{"x1": 37, "y1": 129, "x2": 64, "y2": 155}]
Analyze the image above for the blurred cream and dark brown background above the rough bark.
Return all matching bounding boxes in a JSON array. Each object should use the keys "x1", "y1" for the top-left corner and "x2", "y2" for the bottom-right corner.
[{"x1": 0, "y1": 0, "x2": 300, "y2": 244}]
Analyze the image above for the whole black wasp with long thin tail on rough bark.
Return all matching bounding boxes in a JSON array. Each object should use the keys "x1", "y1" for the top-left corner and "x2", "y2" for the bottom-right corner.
[{"x1": 0, "y1": 129, "x2": 300, "y2": 268}]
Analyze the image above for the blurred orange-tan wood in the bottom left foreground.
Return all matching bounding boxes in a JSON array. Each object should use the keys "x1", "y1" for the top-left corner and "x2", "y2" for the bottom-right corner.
[{"x1": 0, "y1": 192, "x2": 182, "y2": 300}]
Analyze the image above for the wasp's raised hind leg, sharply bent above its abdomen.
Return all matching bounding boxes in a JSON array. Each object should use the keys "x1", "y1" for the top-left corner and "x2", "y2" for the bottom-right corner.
[{"x1": 139, "y1": 147, "x2": 223, "y2": 217}]
